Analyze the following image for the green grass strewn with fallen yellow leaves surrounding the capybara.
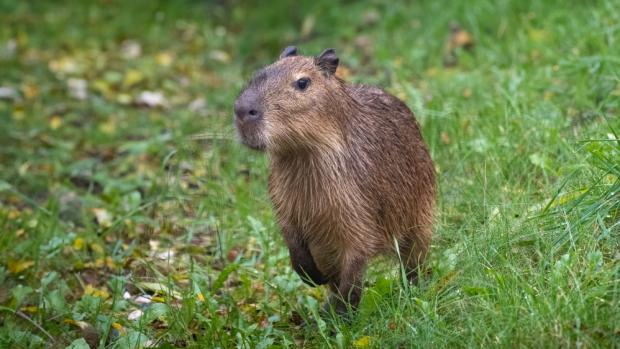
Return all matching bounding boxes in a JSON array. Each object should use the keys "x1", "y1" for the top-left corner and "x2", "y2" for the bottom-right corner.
[{"x1": 0, "y1": 0, "x2": 620, "y2": 348}]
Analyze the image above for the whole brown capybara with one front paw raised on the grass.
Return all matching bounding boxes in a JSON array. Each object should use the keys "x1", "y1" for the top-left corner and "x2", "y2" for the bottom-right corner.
[{"x1": 234, "y1": 46, "x2": 436, "y2": 313}]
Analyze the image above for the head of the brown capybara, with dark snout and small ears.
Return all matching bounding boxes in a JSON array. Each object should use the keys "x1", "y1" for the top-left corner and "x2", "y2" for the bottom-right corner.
[{"x1": 235, "y1": 46, "x2": 342, "y2": 153}]
